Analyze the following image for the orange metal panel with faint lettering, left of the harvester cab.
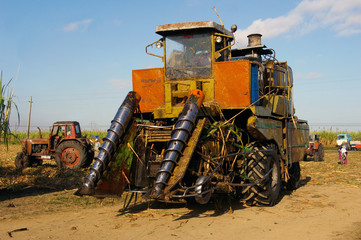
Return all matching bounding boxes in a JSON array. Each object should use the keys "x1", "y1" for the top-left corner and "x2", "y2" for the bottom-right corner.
[{"x1": 132, "y1": 68, "x2": 164, "y2": 112}]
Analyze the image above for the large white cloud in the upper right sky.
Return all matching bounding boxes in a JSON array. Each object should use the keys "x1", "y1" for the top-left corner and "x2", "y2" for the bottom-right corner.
[{"x1": 235, "y1": 0, "x2": 361, "y2": 47}]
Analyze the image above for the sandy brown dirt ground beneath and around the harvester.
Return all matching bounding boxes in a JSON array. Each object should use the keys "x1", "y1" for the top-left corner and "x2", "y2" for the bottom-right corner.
[{"x1": 0, "y1": 144, "x2": 361, "y2": 240}]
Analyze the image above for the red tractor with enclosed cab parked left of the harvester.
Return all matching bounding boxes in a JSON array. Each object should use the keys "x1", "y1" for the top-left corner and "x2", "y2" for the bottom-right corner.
[{"x1": 15, "y1": 121, "x2": 94, "y2": 169}]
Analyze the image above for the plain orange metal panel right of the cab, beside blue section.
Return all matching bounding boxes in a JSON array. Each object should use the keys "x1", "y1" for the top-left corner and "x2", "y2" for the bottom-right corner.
[{"x1": 214, "y1": 60, "x2": 251, "y2": 109}]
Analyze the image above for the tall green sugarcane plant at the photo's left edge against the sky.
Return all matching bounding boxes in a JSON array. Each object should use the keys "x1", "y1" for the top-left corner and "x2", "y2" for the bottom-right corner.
[{"x1": 0, "y1": 72, "x2": 20, "y2": 145}]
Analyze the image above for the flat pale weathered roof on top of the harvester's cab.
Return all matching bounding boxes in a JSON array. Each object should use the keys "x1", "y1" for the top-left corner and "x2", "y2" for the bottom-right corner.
[{"x1": 155, "y1": 21, "x2": 233, "y2": 36}]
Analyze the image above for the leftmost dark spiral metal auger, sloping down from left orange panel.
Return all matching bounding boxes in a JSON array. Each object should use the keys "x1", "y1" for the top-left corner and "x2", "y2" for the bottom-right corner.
[{"x1": 75, "y1": 91, "x2": 140, "y2": 196}]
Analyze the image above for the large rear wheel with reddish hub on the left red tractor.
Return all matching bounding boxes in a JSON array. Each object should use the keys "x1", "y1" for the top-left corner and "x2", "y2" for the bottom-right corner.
[{"x1": 55, "y1": 141, "x2": 88, "y2": 169}]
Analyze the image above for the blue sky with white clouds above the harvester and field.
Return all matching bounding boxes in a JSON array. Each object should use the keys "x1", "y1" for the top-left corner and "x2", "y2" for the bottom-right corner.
[{"x1": 0, "y1": 0, "x2": 361, "y2": 131}]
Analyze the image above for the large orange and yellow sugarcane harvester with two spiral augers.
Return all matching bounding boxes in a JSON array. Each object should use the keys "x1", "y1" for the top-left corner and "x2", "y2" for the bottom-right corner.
[{"x1": 77, "y1": 21, "x2": 309, "y2": 205}]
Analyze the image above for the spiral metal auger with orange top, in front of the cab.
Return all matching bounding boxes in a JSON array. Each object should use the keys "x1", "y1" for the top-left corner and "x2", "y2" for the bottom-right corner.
[{"x1": 149, "y1": 89, "x2": 204, "y2": 199}]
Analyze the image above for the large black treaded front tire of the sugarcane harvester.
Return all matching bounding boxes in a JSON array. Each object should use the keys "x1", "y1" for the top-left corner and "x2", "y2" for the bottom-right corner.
[{"x1": 242, "y1": 142, "x2": 282, "y2": 206}]
